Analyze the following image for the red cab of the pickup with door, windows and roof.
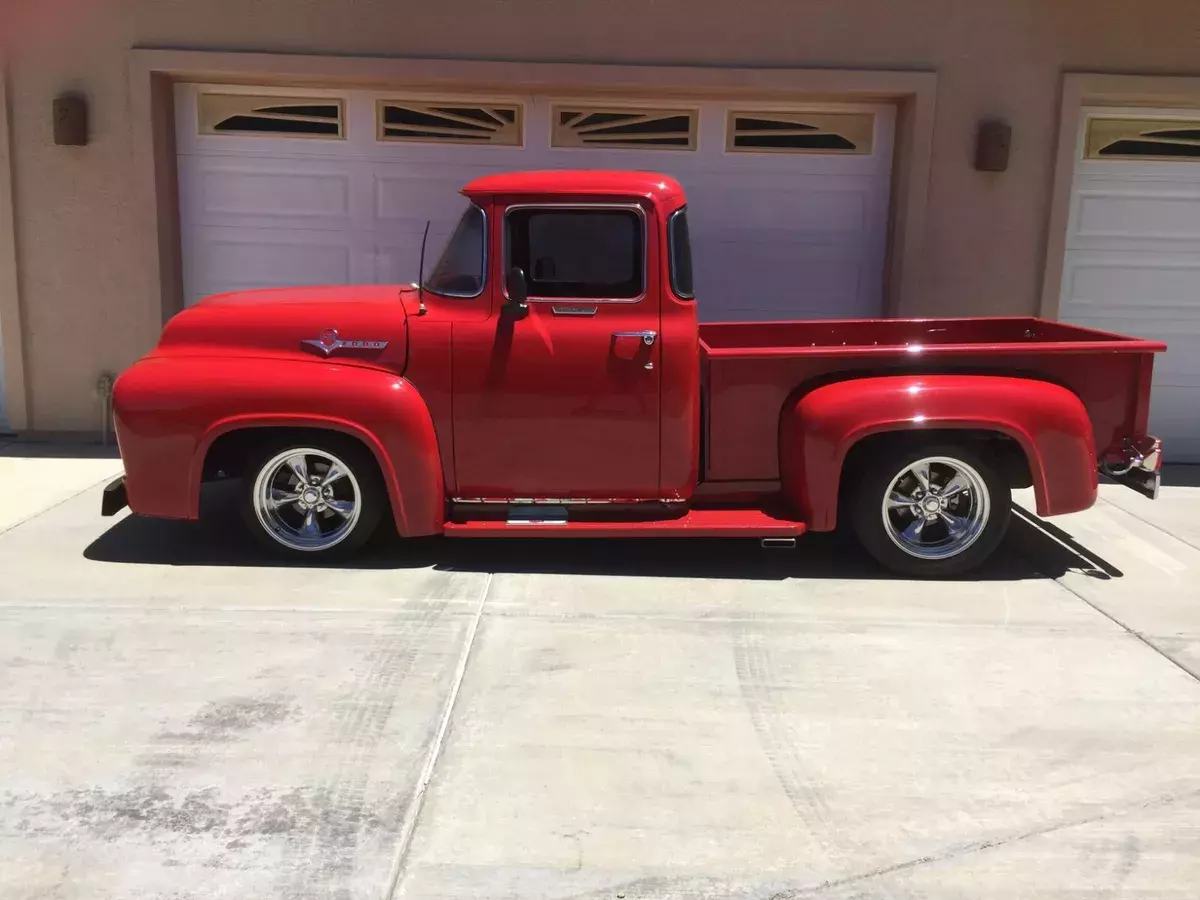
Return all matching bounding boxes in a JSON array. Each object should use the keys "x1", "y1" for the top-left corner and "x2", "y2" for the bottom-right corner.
[{"x1": 422, "y1": 172, "x2": 700, "y2": 502}]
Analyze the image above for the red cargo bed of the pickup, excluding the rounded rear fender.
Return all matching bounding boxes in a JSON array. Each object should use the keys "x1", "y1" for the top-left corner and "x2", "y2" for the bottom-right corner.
[{"x1": 700, "y1": 317, "x2": 1165, "y2": 481}]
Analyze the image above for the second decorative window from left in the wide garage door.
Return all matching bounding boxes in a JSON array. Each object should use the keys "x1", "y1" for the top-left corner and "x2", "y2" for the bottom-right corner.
[{"x1": 376, "y1": 100, "x2": 521, "y2": 146}]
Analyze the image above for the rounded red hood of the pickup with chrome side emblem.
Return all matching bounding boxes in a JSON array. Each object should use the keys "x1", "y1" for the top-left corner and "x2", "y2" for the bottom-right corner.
[{"x1": 150, "y1": 284, "x2": 408, "y2": 372}]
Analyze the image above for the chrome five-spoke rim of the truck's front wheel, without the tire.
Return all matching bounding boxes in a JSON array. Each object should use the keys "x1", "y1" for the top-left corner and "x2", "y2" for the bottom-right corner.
[{"x1": 253, "y1": 448, "x2": 362, "y2": 552}]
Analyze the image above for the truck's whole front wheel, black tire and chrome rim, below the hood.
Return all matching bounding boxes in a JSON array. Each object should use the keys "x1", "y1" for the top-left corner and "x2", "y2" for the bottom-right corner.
[{"x1": 241, "y1": 434, "x2": 386, "y2": 562}]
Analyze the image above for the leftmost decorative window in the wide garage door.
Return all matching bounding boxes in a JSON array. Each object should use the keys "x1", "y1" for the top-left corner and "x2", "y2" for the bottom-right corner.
[{"x1": 197, "y1": 94, "x2": 346, "y2": 139}]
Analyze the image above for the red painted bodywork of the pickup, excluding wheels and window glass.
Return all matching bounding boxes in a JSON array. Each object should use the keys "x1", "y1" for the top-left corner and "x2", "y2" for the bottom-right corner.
[{"x1": 114, "y1": 172, "x2": 1164, "y2": 547}]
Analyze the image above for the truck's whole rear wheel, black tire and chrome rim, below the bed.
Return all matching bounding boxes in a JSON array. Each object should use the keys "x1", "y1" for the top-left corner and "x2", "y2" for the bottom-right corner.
[{"x1": 851, "y1": 444, "x2": 1012, "y2": 577}]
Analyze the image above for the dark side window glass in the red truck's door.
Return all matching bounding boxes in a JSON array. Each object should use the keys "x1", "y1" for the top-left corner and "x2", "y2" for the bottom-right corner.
[{"x1": 505, "y1": 206, "x2": 646, "y2": 300}]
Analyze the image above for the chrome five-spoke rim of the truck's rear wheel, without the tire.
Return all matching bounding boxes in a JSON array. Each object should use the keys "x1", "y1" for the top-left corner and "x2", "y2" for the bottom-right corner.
[{"x1": 882, "y1": 456, "x2": 991, "y2": 559}]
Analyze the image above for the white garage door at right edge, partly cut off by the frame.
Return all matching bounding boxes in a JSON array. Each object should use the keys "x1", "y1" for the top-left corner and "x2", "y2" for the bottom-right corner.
[{"x1": 1060, "y1": 109, "x2": 1200, "y2": 462}]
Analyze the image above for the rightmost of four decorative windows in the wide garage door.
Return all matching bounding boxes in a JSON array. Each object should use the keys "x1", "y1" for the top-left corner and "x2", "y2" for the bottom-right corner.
[{"x1": 725, "y1": 110, "x2": 875, "y2": 155}]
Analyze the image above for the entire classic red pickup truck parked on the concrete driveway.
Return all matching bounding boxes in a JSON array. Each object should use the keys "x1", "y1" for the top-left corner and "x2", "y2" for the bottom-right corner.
[{"x1": 102, "y1": 172, "x2": 1165, "y2": 576}]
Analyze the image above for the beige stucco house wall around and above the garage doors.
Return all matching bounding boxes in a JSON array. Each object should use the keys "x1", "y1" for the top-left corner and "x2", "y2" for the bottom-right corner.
[{"x1": 0, "y1": 0, "x2": 1200, "y2": 431}]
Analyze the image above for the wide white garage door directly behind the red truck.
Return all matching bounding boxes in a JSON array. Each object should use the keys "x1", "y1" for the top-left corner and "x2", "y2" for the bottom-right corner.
[{"x1": 176, "y1": 85, "x2": 894, "y2": 320}]
